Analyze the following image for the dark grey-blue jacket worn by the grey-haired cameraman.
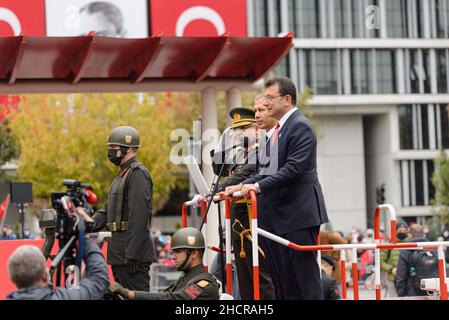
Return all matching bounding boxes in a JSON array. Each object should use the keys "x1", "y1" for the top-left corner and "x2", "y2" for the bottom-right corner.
[{"x1": 6, "y1": 239, "x2": 109, "y2": 300}]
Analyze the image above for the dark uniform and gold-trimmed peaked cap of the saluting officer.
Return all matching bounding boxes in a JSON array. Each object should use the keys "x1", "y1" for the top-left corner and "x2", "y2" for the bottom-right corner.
[{"x1": 214, "y1": 108, "x2": 275, "y2": 300}]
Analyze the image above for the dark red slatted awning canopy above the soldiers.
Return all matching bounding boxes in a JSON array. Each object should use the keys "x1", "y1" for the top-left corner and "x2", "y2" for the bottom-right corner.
[{"x1": 0, "y1": 34, "x2": 292, "y2": 92}]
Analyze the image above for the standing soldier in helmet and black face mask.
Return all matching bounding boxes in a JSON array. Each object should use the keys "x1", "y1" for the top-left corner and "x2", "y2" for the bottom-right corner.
[{"x1": 77, "y1": 126, "x2": 157, "y2": 291}]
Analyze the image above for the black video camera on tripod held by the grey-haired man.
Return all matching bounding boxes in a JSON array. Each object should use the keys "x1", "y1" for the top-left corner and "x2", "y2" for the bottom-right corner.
[{"x1": 39, "y1": 179, "x2": 97, "y2": 284}]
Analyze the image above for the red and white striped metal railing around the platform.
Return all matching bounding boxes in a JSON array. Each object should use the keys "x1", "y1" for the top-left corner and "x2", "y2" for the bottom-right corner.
[{"x1": 182, "y1": 191, "x2": 449, "y2": 300}]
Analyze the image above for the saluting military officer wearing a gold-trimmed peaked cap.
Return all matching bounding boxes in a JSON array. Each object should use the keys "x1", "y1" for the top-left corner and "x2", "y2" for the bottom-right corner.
[{"x1": 214, "y1": 107, "x2": 275, "y2": 300}]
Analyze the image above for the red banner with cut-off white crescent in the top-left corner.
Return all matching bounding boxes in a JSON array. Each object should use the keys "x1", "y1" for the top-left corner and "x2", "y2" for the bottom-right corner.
[{"x1": 0, "y1": 0, "x2": 45, "y2": 36}]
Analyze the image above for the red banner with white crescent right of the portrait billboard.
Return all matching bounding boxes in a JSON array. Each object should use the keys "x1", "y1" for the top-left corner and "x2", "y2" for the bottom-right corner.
[{"x1": 150, "y1": 0, "x2": 246, "y2": 36}]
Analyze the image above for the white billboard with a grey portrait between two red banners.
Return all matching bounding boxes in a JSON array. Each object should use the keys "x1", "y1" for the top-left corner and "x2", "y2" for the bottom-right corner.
[{"x1": 45, "y1": 0, "x2": 149, "y2": 38}]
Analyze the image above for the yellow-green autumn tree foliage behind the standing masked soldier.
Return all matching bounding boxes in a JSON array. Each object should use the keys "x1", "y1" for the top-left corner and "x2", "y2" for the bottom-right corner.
[{"x1": 12, "y1": 93, "x2": 181, "y2": 208}]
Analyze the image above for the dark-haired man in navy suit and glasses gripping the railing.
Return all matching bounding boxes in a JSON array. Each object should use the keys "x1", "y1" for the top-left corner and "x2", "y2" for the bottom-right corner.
[{"x1": 226, "y1": 78, "x2": 329, "y2": 299}]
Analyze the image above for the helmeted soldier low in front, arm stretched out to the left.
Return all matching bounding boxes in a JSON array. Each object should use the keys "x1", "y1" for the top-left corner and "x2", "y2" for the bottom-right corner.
[{"x1": 109, "y1": 228, "x2": 219, "y2": 300}]
